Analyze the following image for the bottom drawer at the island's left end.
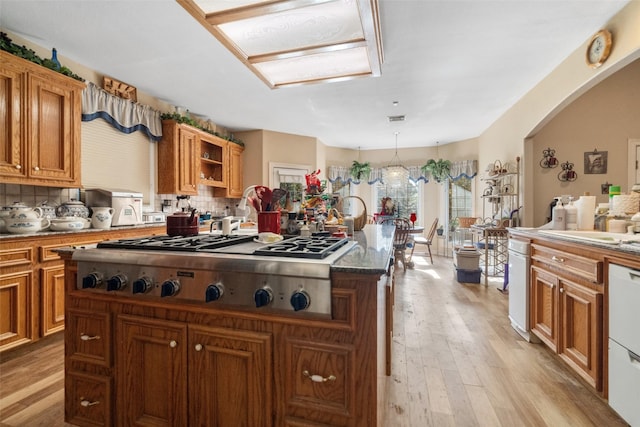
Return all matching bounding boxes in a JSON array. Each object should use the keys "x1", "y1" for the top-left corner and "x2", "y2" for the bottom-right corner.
[{"x1": 64, "y1": 371, "x2": 113, "y2": 426}]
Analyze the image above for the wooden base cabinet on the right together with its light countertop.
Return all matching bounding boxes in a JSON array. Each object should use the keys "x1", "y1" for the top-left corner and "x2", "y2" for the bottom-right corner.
[{"x1": 509, "y1": 228, "x2": 640, "y2": 398}]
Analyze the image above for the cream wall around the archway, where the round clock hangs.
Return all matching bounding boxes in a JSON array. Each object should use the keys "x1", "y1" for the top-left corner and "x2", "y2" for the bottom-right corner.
[{"x1": 478, "y1": 1, "x2": 640, "y2": 226}]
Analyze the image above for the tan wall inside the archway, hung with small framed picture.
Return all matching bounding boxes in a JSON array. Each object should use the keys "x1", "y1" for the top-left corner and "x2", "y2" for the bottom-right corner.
[{"x1": 530, "y1": 60, "x2": 640, "y2": 226}]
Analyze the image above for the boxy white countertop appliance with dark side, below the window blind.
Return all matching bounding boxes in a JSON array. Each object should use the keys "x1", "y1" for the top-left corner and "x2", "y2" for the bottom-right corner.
[{"x1": 85, "y1": 188, "x2": 144, "y2": 226}]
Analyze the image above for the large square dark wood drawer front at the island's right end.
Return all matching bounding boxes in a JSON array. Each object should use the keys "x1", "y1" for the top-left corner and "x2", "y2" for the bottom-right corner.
[{"x1": 285, "y1": 338, "x2": 356, "y2": 425}]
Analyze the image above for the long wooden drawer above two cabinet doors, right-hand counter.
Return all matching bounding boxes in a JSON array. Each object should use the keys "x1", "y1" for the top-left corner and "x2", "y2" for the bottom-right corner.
[{"x1": 531, "y1": 243, "x2": 603, "y2": 283}]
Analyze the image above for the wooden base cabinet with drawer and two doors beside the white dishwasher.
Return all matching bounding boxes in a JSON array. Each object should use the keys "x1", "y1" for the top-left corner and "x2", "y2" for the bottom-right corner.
[{"x1": 530, "y1": 243, "x2": 604, "y2": 391}]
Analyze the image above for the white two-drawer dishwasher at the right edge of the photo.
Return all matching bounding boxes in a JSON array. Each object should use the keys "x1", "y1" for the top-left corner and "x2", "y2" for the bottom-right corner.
[{"x1": 609, "y1": 264, "x2": 640, "y2": 426}]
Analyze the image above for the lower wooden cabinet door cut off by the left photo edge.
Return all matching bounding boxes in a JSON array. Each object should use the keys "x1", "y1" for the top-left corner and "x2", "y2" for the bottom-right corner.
[{"x1": 0, "y1": 271, "x2": 33, "y2": 350}]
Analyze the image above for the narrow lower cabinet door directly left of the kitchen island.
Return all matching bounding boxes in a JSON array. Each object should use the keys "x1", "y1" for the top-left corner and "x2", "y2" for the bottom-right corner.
[{"x1": 40, "y1": 264, "x2": 64, "y2": 336}]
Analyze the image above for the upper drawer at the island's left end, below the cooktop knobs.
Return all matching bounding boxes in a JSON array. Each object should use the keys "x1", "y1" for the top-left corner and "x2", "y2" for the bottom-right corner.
[{"x1": 65, "y1": 309, "x2": 112, "y2": 368}]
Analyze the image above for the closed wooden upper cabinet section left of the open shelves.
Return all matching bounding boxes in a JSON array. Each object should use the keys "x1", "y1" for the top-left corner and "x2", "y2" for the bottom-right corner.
[{"x1": 158, "y1": 120, "x2": 200, "y2": 195}]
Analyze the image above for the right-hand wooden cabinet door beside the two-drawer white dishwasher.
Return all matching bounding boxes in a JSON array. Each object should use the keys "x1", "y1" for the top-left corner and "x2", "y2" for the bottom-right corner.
[{"x1": 558, "y1": 279, "x2": 603, "y2": 391}]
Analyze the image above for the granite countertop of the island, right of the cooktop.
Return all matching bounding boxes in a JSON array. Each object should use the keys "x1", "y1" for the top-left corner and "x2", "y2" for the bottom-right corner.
[{"x1": 331, "y1": 224, "x2": 395, "y2": 274}]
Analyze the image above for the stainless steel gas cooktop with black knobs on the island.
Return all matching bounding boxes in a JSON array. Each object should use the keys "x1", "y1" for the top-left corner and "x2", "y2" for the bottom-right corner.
[{"x1": 73, "y1": 234, "x2": 355, "y2": 317}]
